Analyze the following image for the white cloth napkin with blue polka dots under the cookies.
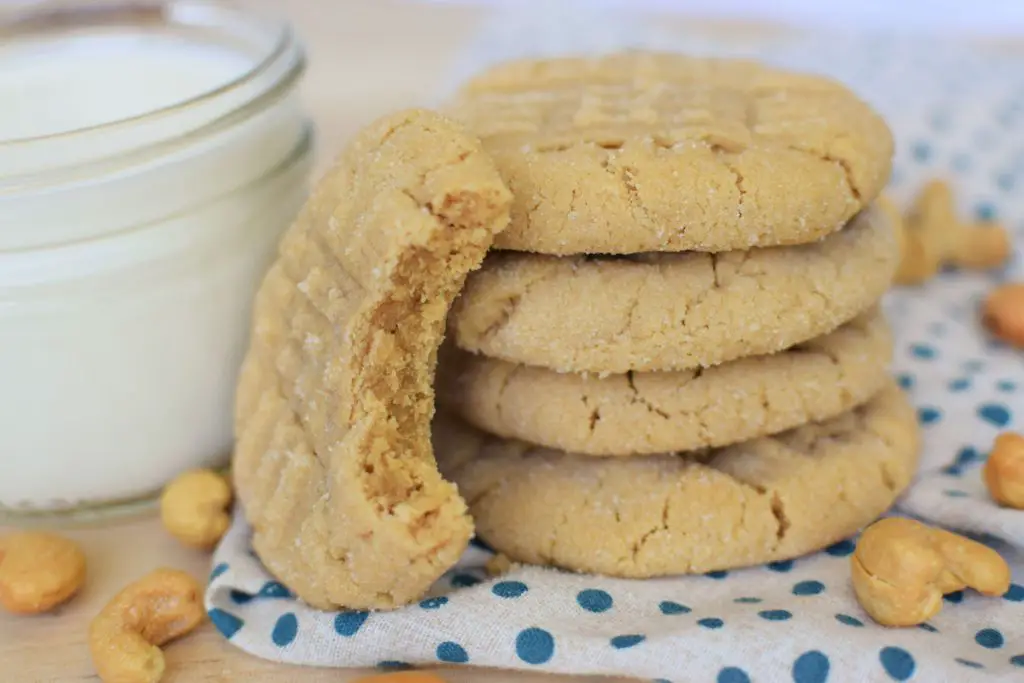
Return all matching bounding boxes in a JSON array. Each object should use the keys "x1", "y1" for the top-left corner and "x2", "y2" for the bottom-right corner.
[{"x1": 206, "y1": 2, "x2": 1024, "y2": 683}]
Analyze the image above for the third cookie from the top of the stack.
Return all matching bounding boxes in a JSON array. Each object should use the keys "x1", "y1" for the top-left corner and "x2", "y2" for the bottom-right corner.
[{"x1": 438, "y1": 311, "x2": 892, "y2": 456}]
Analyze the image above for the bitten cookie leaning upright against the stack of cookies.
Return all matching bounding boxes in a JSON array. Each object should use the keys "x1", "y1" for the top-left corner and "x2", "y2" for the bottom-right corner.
[{"x1": 233, "y1": 111, "x2": 510, "y2": 609}]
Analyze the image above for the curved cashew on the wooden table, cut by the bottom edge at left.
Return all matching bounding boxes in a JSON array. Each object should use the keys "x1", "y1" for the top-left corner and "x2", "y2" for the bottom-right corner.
[{"x1": 89, "y1": 569, "x2": 206, "y2": 683}]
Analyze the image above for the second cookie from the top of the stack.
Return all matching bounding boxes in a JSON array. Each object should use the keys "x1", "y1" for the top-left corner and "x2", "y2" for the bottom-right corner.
[{"x1": 450, "y1": 202, "x2": 899, "y2": 373}]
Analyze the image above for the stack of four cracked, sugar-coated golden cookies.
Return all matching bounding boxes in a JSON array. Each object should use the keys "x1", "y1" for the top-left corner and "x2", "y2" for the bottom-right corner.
[{"x1": 434, "y1": 53, "x2": 918, "y2": 577}]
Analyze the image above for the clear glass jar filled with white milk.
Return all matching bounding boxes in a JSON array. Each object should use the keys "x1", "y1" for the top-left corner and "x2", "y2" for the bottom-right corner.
[{"x1": 0, "y1": 0, "x2": 312, "y2": 517}]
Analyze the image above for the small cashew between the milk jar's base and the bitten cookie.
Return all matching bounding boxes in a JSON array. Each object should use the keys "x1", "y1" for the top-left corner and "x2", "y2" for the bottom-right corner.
[{"x1": 160, "y1": 470, "x2": 231, "y2": 549}]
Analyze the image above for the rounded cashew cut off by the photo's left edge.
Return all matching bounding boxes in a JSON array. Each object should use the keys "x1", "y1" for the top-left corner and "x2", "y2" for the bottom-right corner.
[{"x1": 0, "y1": 531, "x2": 85, "y2": 614}]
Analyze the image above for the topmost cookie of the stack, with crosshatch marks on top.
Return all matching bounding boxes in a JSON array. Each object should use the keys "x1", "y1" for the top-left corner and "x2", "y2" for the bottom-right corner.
[{"x1": 450, "y1": 52, "x2": 893, "y2": 255}]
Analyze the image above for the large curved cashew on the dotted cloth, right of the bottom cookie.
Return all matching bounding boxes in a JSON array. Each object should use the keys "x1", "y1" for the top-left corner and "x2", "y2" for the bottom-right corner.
[{"x1": 850, "y1": 517, "x2": 1010, "y2": 626}]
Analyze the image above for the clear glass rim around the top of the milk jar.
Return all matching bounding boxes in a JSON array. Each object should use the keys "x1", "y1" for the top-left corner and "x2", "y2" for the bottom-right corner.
[{"x1": 0, "y1": 0, "x2": 306, "y2": 189}]
